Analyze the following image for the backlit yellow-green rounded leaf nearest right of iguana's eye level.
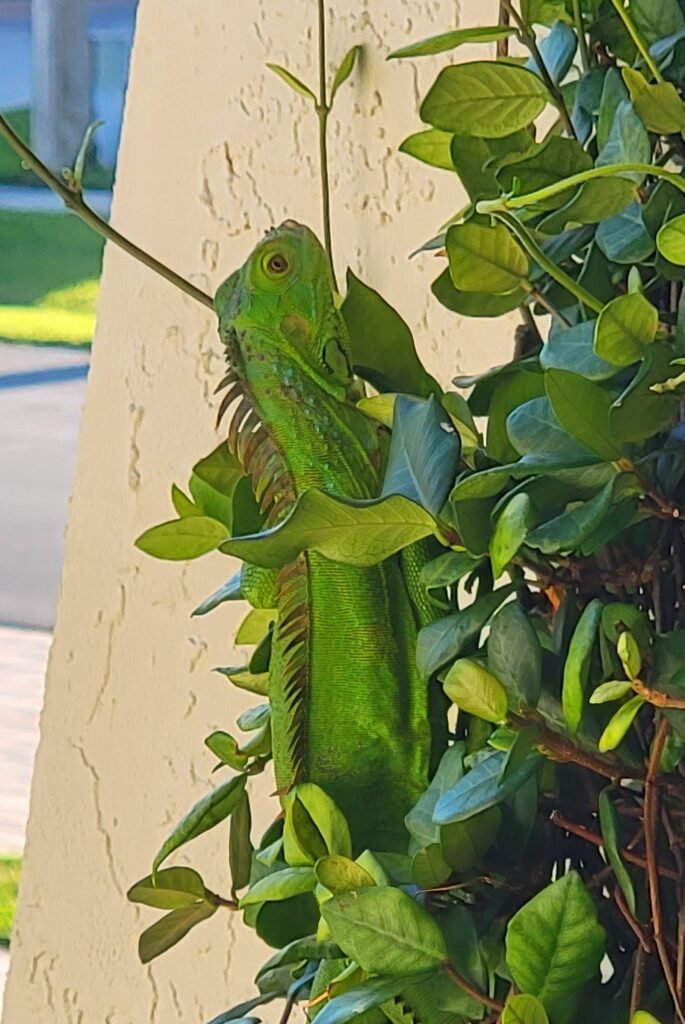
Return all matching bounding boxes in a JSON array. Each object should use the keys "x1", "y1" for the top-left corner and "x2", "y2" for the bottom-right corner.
[{"x1": 445, "y1": 220, "x2": 528, "y2": 295}]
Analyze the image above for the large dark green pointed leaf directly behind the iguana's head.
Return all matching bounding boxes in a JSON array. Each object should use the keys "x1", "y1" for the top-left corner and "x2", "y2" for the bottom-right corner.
[{"x1": 340, "y1": 270, "x2": 442, "y2": 398}]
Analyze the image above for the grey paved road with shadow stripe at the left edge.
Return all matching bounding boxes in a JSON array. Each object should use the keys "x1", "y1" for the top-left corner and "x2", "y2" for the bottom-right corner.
[{"x1": 0, "y1": 343, "x2": 88, "y2": 630}]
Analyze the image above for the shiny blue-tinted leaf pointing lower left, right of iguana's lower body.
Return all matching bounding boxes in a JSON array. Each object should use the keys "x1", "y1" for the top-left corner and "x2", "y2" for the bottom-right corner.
[{"x1": 433, "y1": 751, "x2": 542, "y2": 825}]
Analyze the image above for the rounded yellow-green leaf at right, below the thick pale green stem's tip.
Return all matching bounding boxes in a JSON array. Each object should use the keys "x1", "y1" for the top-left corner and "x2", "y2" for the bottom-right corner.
[{"x1": 595, "y1": 293, "x2": 658, "y2": 367}]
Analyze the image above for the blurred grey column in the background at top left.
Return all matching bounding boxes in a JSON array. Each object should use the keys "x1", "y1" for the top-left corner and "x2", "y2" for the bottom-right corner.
[{"x1": 31, "y1": 0, "x2": 90, "y2": 170}]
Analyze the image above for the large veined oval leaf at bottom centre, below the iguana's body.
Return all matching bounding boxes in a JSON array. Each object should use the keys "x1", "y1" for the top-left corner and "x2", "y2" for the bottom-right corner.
[{"x1": 322, "y1": 886, "x2": 447, "y2": 975}]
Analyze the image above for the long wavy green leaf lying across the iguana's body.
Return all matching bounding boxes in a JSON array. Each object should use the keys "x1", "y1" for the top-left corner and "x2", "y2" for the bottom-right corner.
[{"x1": 219, "y1": 487, "x2": 435, "y2": 568}]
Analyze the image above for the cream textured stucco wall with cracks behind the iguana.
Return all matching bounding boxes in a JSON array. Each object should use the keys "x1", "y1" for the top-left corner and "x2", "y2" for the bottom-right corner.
[{"x1": 3, "y1": 0, "x2": 511, "y2": 1024}]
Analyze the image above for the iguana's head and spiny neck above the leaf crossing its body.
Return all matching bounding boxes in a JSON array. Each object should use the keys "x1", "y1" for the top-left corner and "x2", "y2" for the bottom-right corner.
[{"x1": 215, "y1": 220, "x2": 368, "y2": 523}]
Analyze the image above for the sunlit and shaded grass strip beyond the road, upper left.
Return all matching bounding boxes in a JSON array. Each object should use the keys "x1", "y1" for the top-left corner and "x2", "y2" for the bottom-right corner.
[{"x1": 0, "y1": 210, "x2": 103, "y2": 344}]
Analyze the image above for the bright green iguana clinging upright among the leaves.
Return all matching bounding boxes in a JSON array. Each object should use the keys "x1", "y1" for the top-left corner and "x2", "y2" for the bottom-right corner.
[{"x1": 216, "y1": 221, "x2": 430, "y2": 850}]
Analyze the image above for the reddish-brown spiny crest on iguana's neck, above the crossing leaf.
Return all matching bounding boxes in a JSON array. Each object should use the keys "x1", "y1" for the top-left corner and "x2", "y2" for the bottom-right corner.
[{"x1": 215, "y1": 358, "x2": 295, "y2": 527}]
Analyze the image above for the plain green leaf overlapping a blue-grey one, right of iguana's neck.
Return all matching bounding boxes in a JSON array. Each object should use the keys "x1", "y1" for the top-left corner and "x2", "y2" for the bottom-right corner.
[{"x1": 545, "y1": 370, "x2": 622, "y2": 462}]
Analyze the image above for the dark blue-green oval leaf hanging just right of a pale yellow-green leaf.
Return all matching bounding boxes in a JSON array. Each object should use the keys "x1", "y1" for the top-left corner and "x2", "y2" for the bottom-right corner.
[{"x1": 487, "y1": 601, "x2": 542, "y2": 708}]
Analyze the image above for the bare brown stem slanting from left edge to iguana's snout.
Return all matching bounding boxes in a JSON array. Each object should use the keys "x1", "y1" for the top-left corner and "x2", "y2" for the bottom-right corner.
[{"x1": 0, "y1": 115, "x2": 214, "y2": 309}]
